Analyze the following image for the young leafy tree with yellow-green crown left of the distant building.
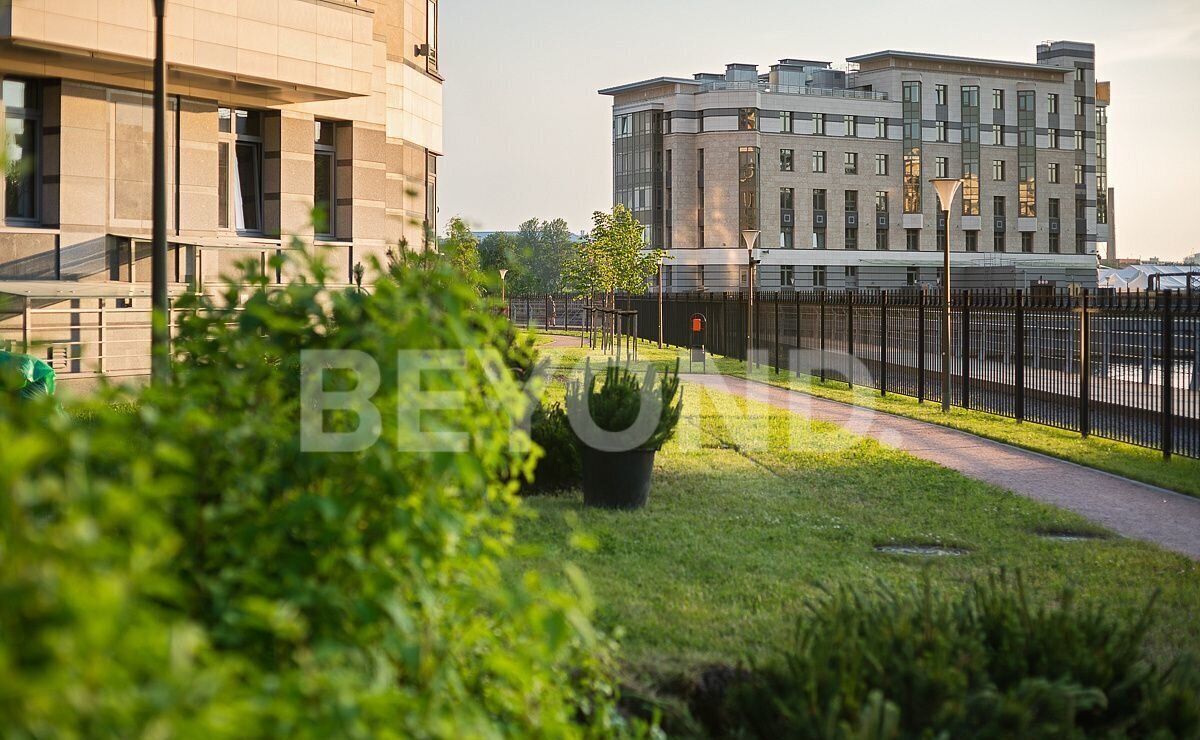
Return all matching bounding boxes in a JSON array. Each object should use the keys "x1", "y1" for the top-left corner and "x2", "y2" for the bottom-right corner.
[{"x1": 564, "y1": 204, "x2": 666, "y2": 307}]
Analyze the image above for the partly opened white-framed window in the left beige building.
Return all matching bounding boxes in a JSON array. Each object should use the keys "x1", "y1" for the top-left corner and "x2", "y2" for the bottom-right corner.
[{"x1": 217, "y1": 108, "x2": 263, "y2": 234}]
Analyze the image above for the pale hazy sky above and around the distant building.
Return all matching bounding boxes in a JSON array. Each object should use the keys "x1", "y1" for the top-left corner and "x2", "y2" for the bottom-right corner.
[{"x1": 438, "y1": 0, "x2": 1200, "y2": 258}]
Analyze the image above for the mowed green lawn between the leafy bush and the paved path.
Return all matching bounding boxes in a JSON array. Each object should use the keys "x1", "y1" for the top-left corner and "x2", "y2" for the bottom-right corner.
[{"x1": 516, "y1": 350, "x2": 1200, "y2": 678}]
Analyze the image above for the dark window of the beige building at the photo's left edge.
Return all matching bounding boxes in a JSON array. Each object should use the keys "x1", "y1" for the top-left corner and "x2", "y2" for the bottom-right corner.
[{"x1": 4, "y1": 78, "x2": 41, "y2": 223}]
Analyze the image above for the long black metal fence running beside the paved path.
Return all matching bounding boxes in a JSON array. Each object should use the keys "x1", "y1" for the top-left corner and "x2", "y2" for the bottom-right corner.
[{"x1": 510, "y1": 289, "x2": 1200, "y2": 458}]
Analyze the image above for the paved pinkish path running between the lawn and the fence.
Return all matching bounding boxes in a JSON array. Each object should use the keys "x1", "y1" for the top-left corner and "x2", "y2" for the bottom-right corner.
[{"x1": 680, "y1": 374, "x2": 1200, "y2": 560}]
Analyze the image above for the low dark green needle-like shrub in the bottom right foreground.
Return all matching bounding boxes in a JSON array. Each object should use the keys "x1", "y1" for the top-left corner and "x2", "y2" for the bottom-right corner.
[{"x1": 722, "y1": 574, "x2": 1200, "y2": 739}]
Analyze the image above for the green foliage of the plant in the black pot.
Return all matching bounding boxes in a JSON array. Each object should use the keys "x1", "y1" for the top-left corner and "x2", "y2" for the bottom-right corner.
[{"x1": 566, "y1": 360, "x2": 683, "y2": 450}]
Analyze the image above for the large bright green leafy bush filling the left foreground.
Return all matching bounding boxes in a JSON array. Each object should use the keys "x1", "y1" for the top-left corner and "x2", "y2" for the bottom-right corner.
[{"x1": 0, "y1": 250, "x2": 624, "y2": 738}]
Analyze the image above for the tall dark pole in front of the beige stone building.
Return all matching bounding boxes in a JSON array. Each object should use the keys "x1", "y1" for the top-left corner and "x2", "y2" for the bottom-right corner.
[{"x1": 150, "y1": 0, "x2": 170, "y2": 384}]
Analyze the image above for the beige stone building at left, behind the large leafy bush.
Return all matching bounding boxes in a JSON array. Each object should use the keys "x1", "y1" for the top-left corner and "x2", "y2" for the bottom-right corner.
[{"x1": 0, "y1": 0, "x2": 443, "y2": 377}]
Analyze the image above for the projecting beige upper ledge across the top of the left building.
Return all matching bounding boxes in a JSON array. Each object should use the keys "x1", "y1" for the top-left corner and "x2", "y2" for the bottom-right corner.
[{"x1": 0, "y1": 0, "x2": 374, "y2": 103}]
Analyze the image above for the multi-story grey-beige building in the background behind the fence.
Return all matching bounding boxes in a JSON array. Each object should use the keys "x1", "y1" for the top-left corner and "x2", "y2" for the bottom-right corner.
[{"x1": 601, "y1": 42, "x2": 1110, "y2": 290}]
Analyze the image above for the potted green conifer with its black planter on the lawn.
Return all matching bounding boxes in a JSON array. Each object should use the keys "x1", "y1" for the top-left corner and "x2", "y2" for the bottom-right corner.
[{"x1": 566, "y1": 361, "x2": 683, "y2": 509}]
